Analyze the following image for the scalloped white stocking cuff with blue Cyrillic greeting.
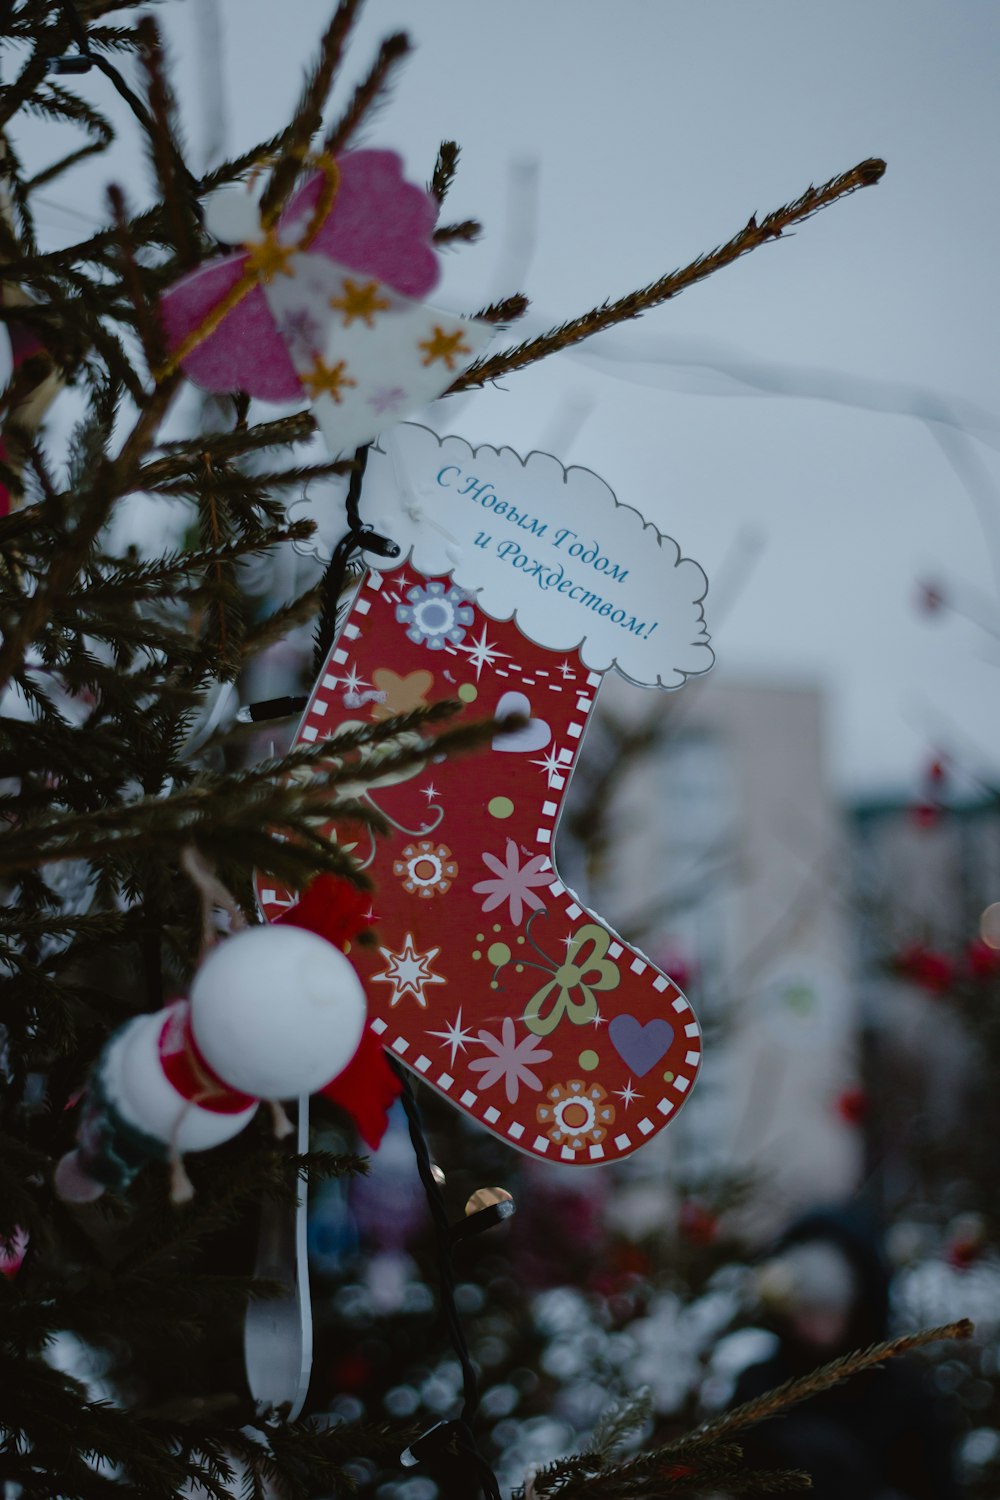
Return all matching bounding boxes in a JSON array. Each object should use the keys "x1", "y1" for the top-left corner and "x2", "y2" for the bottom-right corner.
[{"x1": 361, "y1": 423, "x2": 714, "y2": 687}]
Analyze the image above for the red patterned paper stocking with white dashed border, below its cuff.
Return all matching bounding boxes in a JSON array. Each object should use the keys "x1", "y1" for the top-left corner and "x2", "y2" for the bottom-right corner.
[{"x1": 258, "y1": 567, "x2": 702, "y2": 1164}]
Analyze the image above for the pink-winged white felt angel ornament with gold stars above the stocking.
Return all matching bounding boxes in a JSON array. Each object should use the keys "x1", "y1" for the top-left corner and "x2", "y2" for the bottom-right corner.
[{"x1": 160, "y1": 152, "x2": 492, "y2": 453}]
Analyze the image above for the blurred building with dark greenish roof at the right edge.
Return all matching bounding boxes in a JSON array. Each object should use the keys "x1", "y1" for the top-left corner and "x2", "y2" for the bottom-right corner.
[{"x1": 850, "y1": 779, "x2": 1000, "y2": 1218}]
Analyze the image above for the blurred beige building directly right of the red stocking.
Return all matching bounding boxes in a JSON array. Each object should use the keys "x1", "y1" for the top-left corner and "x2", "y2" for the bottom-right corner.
[{"x1": 556, "y1": 674, "x2": 864, "y2": 1236}]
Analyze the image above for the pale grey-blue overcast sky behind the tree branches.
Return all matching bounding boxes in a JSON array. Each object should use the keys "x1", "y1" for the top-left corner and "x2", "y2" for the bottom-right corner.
[{"x1": 19, "y1": 0, "x2": 1000, "y2": 791}]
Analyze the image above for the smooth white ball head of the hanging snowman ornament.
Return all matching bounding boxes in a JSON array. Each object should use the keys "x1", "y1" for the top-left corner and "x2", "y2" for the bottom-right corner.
[{"x1": 190, "y1": 926, "x2": 367, "y2": 1100}]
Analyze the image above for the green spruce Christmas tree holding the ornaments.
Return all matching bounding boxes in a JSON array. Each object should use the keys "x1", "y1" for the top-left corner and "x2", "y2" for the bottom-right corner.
[{"x1": 0, "y1": 0, "x2": 971, "y2": 1497}]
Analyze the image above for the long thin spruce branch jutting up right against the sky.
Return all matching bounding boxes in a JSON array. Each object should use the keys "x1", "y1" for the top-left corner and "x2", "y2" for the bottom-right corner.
[{"x1": 447, "y1": 159, "x2": 886, "y2": 395}]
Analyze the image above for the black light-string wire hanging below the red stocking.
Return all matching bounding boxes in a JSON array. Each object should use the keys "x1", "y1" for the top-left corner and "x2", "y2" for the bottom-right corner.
[{"x1": 385, "y1": 1053, "x2": 501, "y2": 1500}]
